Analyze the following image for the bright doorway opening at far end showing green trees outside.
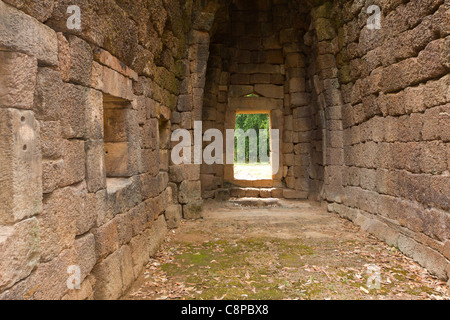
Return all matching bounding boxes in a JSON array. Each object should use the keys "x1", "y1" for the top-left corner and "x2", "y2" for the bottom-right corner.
[{"x1": 234, "y1": 111, "x2": 272, "y2": 181}]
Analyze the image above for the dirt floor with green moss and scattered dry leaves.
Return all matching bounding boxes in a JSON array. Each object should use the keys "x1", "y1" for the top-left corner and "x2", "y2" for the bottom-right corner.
[{"x1": 124, "y1": 200, "x2": 450, "y2": 300}]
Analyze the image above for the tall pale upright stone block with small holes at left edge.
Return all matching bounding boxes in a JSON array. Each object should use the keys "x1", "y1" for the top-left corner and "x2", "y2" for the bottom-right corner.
[{"x1": 0, "y1": 108, "x2": 42, "y2": 224}]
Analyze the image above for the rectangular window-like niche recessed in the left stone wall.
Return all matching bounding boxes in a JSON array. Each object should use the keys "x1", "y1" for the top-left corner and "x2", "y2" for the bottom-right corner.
[{"x1": 103, "y1": 94, "x2": 138, "y2": 178}]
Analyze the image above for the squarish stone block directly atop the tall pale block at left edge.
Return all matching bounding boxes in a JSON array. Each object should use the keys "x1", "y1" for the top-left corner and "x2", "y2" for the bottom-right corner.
[{"x1": 0, "y1": 51, "x2": 37, "y2": 109}]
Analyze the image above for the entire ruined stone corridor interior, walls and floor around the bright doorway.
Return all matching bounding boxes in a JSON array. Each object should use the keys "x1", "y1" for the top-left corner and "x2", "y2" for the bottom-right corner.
[{"x1": 0, "y1": 0, "x2": 450, "y2": 300}]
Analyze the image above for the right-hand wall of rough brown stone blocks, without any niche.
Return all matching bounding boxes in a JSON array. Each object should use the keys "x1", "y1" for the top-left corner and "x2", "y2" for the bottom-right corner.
[{"x1": 305, "y1": 0, "x2": 450, "y2": 280}]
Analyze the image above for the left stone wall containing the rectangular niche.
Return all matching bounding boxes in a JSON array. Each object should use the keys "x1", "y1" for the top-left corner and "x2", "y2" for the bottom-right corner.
[{"x1": 0, "y1": 0, "x2": 211, "y2": 299}]
